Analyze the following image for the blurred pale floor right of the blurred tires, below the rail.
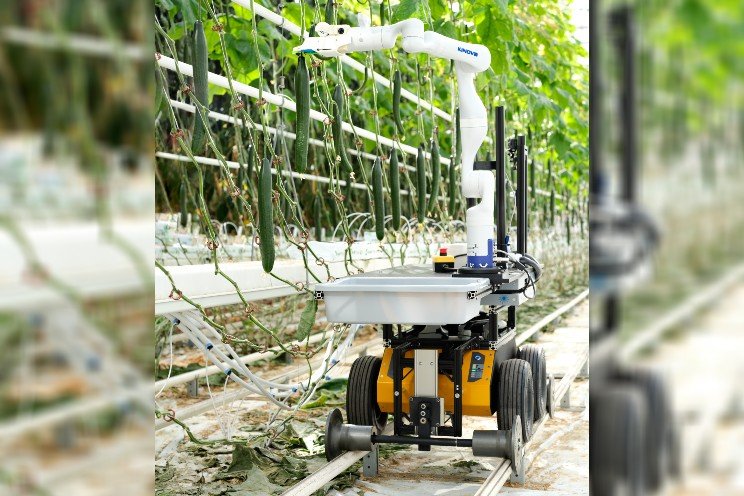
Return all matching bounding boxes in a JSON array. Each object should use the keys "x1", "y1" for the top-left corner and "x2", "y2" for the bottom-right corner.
[{"x1": 639, "y1": 284, "x2": 744, "y2": 496}]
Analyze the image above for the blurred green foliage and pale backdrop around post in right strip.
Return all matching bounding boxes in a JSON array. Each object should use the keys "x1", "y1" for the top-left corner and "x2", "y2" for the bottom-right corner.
[{"x1": 592, "y1": 0, "x2": 744, "y2": 333}]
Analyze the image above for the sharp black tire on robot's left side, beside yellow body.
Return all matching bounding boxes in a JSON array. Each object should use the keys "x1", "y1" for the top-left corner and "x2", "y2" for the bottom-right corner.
[{"x1": 346, "y1": 356, "x2": 387, "y2": 433}]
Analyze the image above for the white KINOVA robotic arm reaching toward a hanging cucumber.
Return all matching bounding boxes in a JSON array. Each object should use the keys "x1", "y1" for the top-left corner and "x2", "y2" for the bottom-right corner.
[{"x1": 294, "y1": 17, "x2": 496, "y2": 268}]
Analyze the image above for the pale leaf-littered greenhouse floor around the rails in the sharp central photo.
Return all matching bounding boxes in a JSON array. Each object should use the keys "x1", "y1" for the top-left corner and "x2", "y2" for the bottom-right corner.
[{"x1": 156, "y1": 302, "x2": 589, "y2": 496}]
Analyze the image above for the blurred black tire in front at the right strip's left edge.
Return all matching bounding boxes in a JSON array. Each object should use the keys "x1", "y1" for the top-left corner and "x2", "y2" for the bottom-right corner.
[{"x1": 589, "y1": 385, "x2": 646, "y2": 496}]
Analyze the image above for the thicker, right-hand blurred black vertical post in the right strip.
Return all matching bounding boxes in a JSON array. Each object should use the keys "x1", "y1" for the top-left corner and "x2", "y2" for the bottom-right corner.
[{"x1": 611, "y1": 7, "x2": 638, "y2": 203}]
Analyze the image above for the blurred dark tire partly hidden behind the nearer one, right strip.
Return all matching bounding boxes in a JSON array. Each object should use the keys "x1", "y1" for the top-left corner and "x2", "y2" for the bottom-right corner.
[{"x1": 618, "y1": 369, "x2": 675, "y2": 492}]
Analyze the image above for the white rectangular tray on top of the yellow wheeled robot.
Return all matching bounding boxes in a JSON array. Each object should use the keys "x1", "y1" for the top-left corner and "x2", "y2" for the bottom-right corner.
[{"x1": 315, "y1": 265, "x2": 489, "y2": 325}]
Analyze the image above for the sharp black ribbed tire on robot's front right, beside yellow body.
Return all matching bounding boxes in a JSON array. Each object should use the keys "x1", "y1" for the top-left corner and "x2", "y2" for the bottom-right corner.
[{"x1": 498, "y1": 358, "x2": 535, "y2": 443}]
